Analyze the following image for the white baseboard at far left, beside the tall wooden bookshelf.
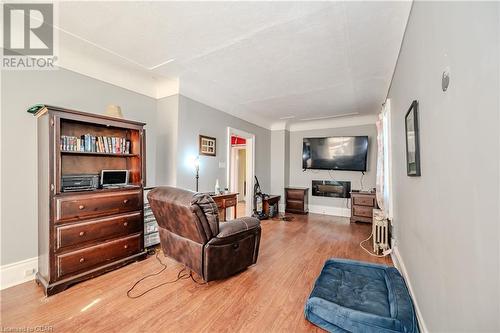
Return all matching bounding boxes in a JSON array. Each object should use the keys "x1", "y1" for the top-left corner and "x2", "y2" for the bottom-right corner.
[{"x1": 0, "y1": 257, "x2": 38, "y2": 290}]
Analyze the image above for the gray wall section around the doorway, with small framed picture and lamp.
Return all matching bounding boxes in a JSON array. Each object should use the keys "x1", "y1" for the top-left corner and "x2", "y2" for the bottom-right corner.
[{"x1": 176, "y1": 95, "x2": 271, "y2": 192}]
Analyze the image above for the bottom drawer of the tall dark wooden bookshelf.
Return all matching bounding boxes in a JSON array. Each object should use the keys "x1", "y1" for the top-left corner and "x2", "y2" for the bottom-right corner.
[{"x1": 56, "y1": 234, "x2": 142, "y2": 277}]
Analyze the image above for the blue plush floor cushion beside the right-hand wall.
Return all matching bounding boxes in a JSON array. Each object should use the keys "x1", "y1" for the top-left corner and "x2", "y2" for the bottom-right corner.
[{"x1": 305, "y1": 259, "x2": 419, "y2": 333}]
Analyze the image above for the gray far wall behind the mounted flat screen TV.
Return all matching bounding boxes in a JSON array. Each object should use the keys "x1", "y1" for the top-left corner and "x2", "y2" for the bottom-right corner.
[{"x1": 288, "y1": 125, "x2": 377, "y2": 214}]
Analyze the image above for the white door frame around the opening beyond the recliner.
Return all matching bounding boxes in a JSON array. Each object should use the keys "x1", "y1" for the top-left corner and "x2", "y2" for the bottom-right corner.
[{"x1": 226, "y1": 127, "x2": 255, "y2": 216}]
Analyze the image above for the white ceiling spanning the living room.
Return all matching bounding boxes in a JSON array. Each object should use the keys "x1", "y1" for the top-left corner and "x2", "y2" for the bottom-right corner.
[{"x1": 57, "y1": 1, "x2": 411, "y2": 127}]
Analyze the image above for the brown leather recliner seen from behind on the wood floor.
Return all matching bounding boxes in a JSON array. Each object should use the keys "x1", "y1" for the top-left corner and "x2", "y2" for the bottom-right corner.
[{"x1": 148, "y1": 186, "x2": 261, "y2": 282}]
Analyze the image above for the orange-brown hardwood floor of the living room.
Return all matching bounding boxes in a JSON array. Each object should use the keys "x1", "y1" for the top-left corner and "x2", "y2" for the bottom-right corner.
[{"x1": 0, "y1": 214, "x2": 392, "y2": 332}]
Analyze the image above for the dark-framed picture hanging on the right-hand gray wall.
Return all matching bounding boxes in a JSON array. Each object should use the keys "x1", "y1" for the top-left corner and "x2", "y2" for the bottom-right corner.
[{"x1": 405, "y1": 101, "x2": 420, "y2": 177}]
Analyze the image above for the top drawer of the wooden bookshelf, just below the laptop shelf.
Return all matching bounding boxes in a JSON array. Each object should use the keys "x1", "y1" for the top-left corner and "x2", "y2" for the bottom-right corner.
[{"x1": 55, "y1": 190, "x2": 143, "y2": 222}]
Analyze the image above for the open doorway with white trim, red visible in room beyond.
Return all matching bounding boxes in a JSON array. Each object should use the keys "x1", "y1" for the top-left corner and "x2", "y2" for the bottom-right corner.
[{"x1": 227, "y1": 127, "x2": 255, "y2": 216}]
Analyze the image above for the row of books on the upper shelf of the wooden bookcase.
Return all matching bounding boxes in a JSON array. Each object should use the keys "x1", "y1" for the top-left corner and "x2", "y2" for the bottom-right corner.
[{"x1": 61, "y1": 134, "x2": 130, "y2": 154}]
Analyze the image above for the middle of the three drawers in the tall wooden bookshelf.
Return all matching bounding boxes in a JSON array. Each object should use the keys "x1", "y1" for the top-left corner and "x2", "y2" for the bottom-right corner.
[{"x1": 56, "y1": 211, "x2": 142, "y2": 249}]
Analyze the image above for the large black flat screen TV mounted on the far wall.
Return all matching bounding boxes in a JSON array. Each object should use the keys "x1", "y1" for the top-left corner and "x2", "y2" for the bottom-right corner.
[{"x1": 302, "y1": 136, "x2": 368, "y2": 172}]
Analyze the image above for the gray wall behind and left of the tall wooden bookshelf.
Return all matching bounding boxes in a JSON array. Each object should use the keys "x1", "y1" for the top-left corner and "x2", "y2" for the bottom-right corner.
[{"x1": 1, "y1": 69, "x2": 157, "y2": 265}]
